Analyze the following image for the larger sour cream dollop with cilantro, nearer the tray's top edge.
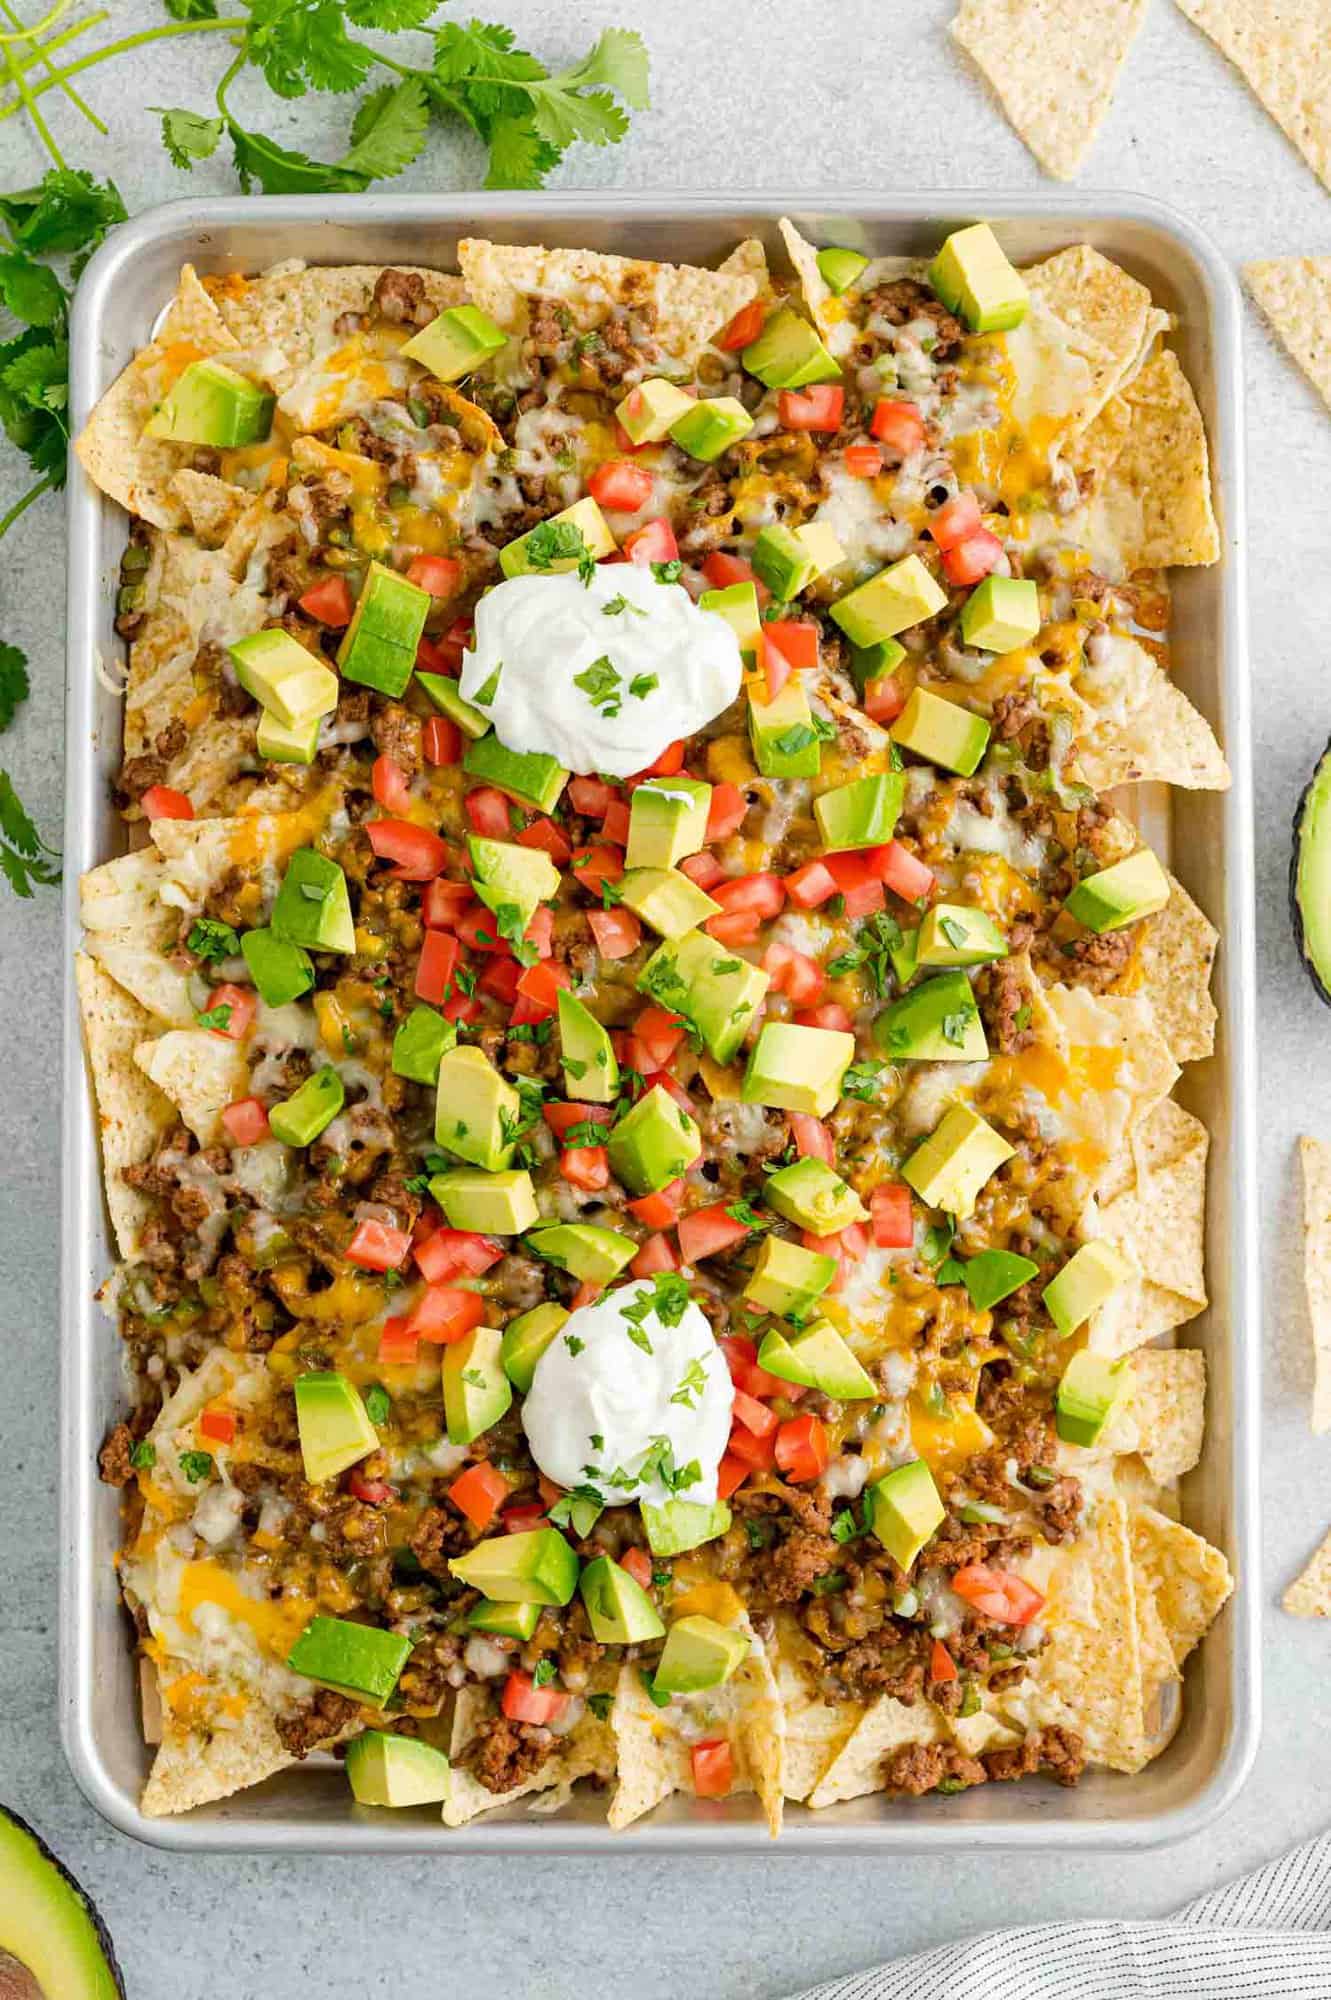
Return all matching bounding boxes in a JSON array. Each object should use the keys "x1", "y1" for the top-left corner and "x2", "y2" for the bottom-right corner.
[{"x1": 462, "y1": 562, "x2": 741, "y2": 778}]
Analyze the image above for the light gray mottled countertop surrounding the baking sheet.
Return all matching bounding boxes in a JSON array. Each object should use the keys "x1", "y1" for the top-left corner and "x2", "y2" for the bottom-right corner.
[{"x1": 0, "y1": 0, "x2": 1331, "y2": 2000}]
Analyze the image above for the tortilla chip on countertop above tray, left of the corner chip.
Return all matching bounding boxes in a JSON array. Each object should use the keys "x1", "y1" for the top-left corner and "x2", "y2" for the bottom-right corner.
[{"x1": 951, "y1": 0, "x2": 1147, "y2": 180}]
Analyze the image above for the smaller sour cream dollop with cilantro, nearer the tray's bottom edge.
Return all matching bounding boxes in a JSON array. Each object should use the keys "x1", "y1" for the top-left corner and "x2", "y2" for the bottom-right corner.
[{"x1": 522, "y1": 1278, "x2": 731, "y2": 1506}]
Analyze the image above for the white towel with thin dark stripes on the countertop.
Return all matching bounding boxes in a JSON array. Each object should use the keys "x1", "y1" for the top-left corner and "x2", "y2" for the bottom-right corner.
[{"x1": 799, "y1": 1834, "x2": 1331, "y2": 2000}]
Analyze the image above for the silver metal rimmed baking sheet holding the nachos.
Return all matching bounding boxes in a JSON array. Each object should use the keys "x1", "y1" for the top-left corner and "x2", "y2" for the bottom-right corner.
[{"x1": 60, "y1": 192, "x2": 1261, "y2": 1856}]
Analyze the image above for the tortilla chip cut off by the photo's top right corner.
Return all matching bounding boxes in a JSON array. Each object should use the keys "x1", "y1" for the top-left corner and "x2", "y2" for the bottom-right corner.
[{"x1": 1177, "y1": 0, "x2": 1331, "y2": 188}]
